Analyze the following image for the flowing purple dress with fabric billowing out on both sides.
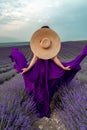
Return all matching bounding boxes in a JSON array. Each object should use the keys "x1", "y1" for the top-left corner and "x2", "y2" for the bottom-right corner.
[{"x1": 10, "y1": 45, "x2": 87, "y2": 117}]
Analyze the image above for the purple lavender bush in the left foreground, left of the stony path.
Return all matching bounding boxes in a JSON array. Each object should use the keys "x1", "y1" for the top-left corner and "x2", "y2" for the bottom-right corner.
[{"x1": 0, "y1": 91, "x2": 37, "y2": 130}]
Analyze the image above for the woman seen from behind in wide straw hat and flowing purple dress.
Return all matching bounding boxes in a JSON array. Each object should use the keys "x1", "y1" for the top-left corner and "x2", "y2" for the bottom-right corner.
[{"x1": 10, "y1": 26, "x2": 87, "y2": 118}]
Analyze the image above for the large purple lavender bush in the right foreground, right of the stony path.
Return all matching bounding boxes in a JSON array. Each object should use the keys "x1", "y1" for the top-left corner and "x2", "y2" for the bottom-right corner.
[{"x1": 54, "y1": 80, "x2": 87, "y2": 130}]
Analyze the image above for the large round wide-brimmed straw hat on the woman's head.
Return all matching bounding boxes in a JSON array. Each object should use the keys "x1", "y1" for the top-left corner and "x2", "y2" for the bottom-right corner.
[{"x1": 30, "y1": 28, "x2": 61, "y2": 59}]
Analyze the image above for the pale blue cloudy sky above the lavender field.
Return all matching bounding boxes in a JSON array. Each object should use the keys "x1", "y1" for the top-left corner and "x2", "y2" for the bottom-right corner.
[{"x1": 0, "y1": 0, "x2": 87, "y2": 42}]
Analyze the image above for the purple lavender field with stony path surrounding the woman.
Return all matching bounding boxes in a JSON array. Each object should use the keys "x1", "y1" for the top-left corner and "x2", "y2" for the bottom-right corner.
[{"x1": 0, "y1": 41, "x2": 87, "y2": 130}]
